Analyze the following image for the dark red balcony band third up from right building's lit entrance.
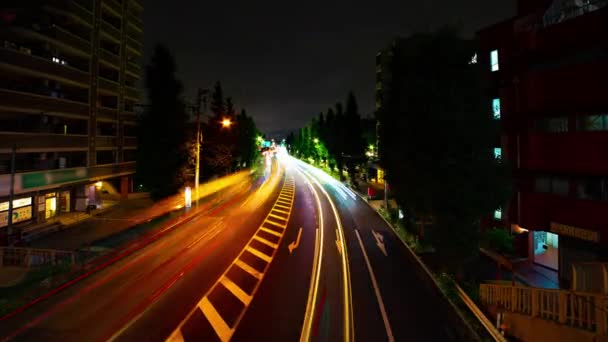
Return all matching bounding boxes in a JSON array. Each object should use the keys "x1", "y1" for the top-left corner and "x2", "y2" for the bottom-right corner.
[{"x1": 519, "y1": 61, "x2": 608, "y2": 113}]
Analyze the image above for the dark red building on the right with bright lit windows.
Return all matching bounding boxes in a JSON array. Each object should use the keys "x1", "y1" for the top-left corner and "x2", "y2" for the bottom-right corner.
[{"x1": 478, "y1": 0, "x2": 608, "y2": 286}]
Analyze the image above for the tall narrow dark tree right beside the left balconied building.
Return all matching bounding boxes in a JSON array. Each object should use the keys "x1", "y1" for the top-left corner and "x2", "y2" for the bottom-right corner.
[{"x1": 137, "y1": 45, "x2": 188, "y2": 199}]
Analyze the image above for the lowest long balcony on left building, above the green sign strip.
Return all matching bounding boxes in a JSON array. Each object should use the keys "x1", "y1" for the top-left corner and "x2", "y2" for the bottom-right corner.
[{"x1": 0, "y1": 132, "x2": 88, "y2": 151}]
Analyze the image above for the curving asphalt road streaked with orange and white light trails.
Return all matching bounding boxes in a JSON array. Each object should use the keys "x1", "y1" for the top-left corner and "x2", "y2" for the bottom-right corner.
[{"x1": 0, "y1": 156, "x2": 470, "y2": 342}]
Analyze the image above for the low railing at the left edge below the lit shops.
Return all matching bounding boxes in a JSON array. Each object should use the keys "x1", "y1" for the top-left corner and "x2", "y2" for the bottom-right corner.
[{"x1": 0, "y1": 247, "x2": 76, "y2": 268}]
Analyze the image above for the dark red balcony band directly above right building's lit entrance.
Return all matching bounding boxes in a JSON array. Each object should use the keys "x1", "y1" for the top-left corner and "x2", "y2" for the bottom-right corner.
[{"x1": 519, "y1": 192, "x2": 608, "y2": 242}]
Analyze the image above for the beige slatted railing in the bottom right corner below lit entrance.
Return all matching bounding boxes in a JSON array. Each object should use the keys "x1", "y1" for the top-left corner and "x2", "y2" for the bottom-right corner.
[{"x1": 479, "y1": 284, "x2": 608, "y2": 335}]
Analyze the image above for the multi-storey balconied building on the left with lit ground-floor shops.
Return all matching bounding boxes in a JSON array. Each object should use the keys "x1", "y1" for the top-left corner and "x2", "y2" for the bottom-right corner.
[{"x1": 0, "y1": 0, "x2": 143, "y2": 240}]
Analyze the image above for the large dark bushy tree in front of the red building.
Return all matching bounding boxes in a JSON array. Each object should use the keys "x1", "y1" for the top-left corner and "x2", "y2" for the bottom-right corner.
[{"x1": 376, "y1": 30, "x2": 510, "y2": 273}]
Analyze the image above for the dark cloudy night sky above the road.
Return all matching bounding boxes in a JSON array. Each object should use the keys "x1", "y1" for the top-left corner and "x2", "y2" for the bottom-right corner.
[{"x1": 144, "y1": 0, "x2": 515, "y2": 133}]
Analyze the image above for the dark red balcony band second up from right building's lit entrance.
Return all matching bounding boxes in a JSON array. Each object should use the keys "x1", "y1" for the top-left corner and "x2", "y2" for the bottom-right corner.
[{"x1": 521, "y1": 131, "x2": 608, "y2": 174}]
